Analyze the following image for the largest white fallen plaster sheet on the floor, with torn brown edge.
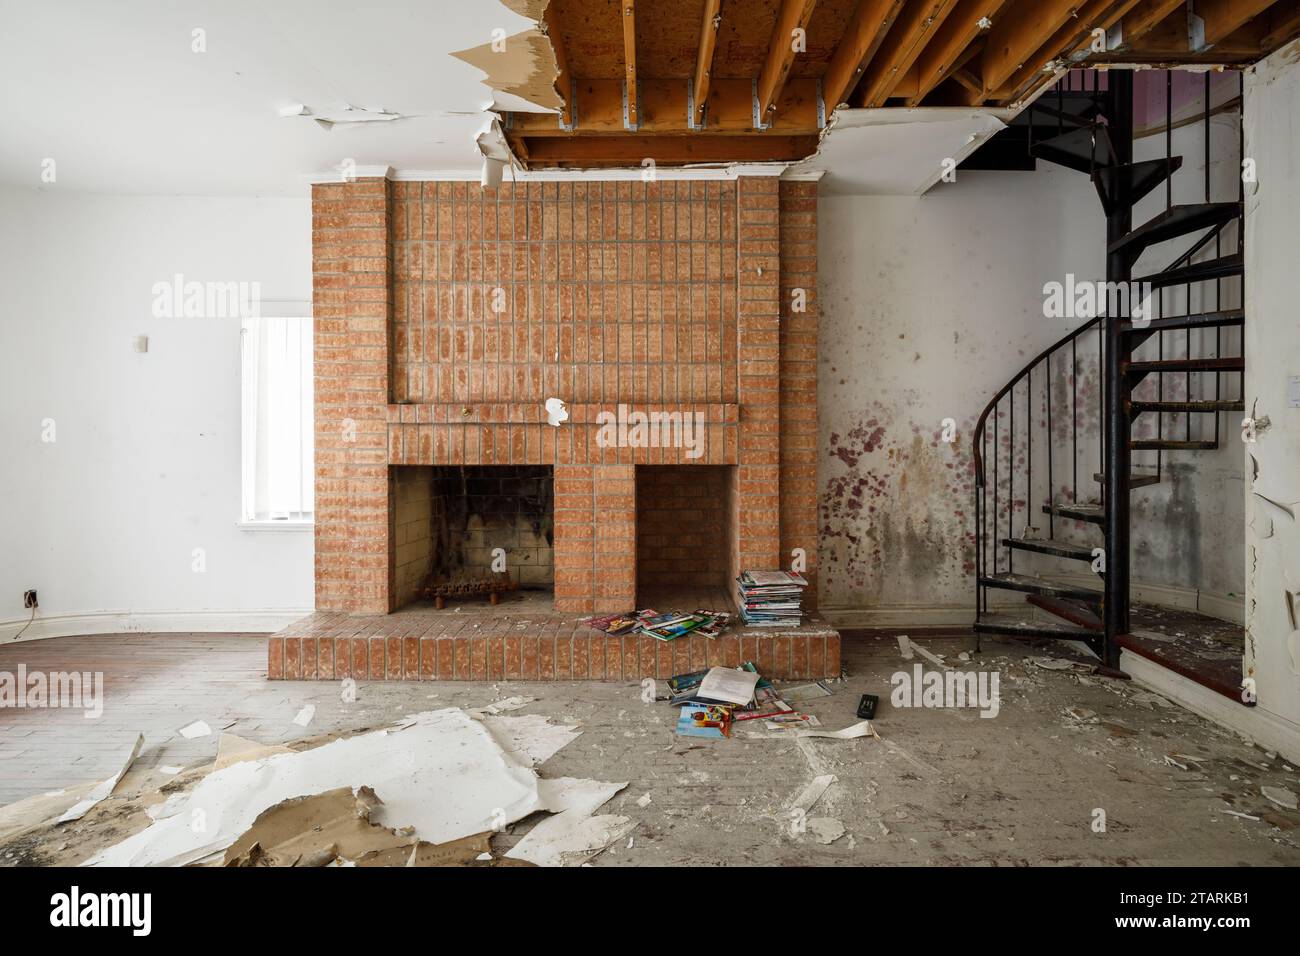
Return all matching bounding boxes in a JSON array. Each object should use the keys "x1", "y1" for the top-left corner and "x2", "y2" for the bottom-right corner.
[{"x1": 87, "y1": 708, "x2": 559, "y2": 866}]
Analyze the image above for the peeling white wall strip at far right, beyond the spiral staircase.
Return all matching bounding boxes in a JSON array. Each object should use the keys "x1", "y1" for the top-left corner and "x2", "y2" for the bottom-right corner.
[{"x1": 1243, "y1": 43, "x2": 1300, "y2": 735}]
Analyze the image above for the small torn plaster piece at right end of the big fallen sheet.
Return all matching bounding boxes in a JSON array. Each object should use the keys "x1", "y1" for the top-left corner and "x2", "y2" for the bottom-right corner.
[{"x1": 506, "y1": 777, "x2": 636, "y2": 866}]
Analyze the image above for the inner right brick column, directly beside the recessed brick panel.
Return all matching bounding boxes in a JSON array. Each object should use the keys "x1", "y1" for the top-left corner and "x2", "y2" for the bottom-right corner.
[{"x1": 732, "y1": 177, "x2": 788, "y2": 580}]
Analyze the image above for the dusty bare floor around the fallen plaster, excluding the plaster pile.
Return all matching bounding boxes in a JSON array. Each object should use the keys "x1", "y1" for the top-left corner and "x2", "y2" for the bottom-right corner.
[{"x1": 0, "y1": 632, "x2": 1300, "y2": 866}]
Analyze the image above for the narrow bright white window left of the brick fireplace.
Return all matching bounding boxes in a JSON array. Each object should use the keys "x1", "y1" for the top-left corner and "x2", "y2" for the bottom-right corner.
[{"x1": 238, "y1": 308, "x2": 316, "y2": 531}]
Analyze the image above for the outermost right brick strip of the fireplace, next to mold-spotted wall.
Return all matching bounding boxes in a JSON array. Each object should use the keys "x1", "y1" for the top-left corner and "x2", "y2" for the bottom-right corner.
[{"x1": 780, "y1": 182, "x2": 820, "y2": 609}]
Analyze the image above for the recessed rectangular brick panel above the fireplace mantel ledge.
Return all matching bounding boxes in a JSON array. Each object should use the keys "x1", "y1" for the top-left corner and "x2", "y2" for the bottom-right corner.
[{"x1": 391, "y1": 181, "x2": 737, "y2": 403}]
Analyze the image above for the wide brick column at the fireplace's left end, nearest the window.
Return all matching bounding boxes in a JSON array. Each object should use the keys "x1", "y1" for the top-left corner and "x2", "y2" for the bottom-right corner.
[{"x1": 312, "y1": 179, "x2": 394, "y2": 614}]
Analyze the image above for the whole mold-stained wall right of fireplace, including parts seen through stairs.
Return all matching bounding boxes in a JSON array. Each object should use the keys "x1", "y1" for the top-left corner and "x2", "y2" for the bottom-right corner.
[{"x1": 818, "y1": 121, "x2": 1244, "y2": 626}]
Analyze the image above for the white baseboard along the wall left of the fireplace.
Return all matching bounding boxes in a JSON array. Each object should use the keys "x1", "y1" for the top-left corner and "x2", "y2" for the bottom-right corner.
[{"x1": 0, "y1": 607, "x2": 312, "y2": 644}]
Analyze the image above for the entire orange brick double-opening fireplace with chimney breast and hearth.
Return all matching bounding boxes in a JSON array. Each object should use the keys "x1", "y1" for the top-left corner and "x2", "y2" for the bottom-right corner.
[{"x1": 269, "y1": 177, "x2": 839, "y2": 678}]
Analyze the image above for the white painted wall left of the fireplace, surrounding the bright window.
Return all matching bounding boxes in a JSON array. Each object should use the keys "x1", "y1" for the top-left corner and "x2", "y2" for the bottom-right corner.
[{"x1": 0, "y1": 189, "x2": 313, "y2": 640}]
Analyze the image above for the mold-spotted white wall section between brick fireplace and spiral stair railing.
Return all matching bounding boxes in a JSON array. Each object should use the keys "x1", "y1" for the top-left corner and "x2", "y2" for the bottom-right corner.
[{"x1": 818, "y1": 165, "x2": 1105, "y2": 626}]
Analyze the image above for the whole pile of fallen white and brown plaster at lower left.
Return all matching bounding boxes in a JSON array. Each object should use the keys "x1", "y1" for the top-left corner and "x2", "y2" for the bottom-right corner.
[{"x1": 0, "y1": 698, "x2": 634, "y2": 866}]
